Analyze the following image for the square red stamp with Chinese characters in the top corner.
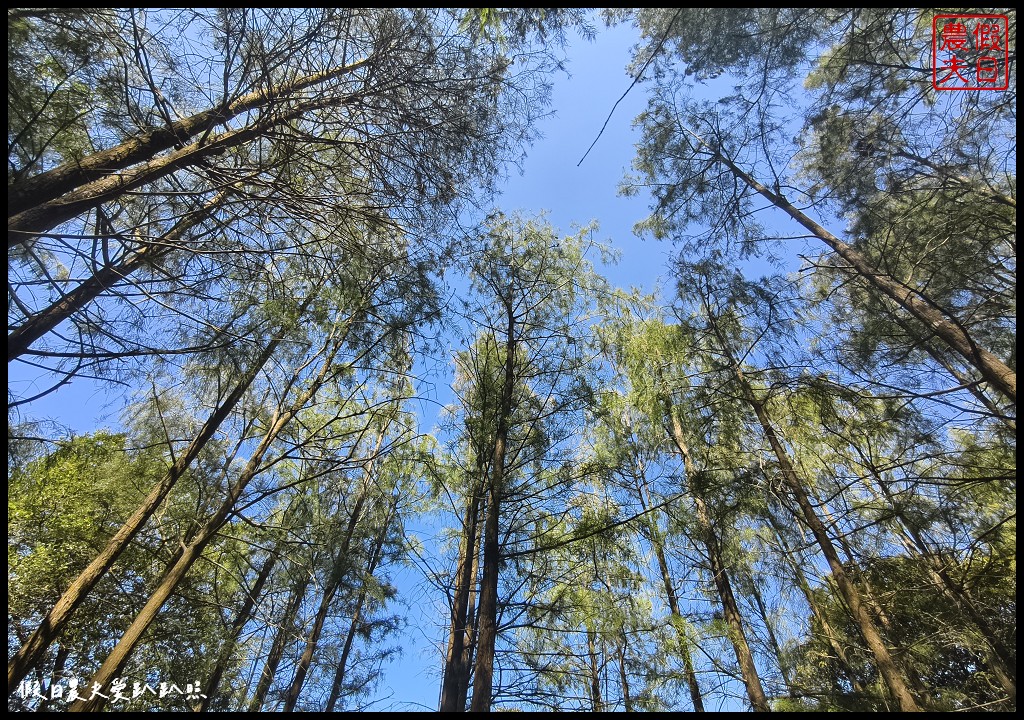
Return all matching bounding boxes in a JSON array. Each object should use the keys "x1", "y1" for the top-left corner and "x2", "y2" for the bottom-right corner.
[{"x1": 932, "y1": 14, "x2": 1010, "y2": 90}]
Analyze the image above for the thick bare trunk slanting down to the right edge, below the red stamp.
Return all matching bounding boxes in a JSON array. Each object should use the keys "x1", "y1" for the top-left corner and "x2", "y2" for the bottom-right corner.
[{"x1": 700, "y1": 146, "x2": 1017, "y2": 405}]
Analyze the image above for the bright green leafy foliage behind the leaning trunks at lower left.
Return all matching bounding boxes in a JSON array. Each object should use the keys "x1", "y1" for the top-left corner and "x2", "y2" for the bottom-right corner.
[{"x1": 7, "y1": 431, "x2": 232, "y2": 709}]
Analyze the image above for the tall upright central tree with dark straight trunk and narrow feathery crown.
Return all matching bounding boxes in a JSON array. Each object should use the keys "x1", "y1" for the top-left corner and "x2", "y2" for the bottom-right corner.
[{"x1": 432, "y1": 210, "x2": 601, "y2": 712}]
